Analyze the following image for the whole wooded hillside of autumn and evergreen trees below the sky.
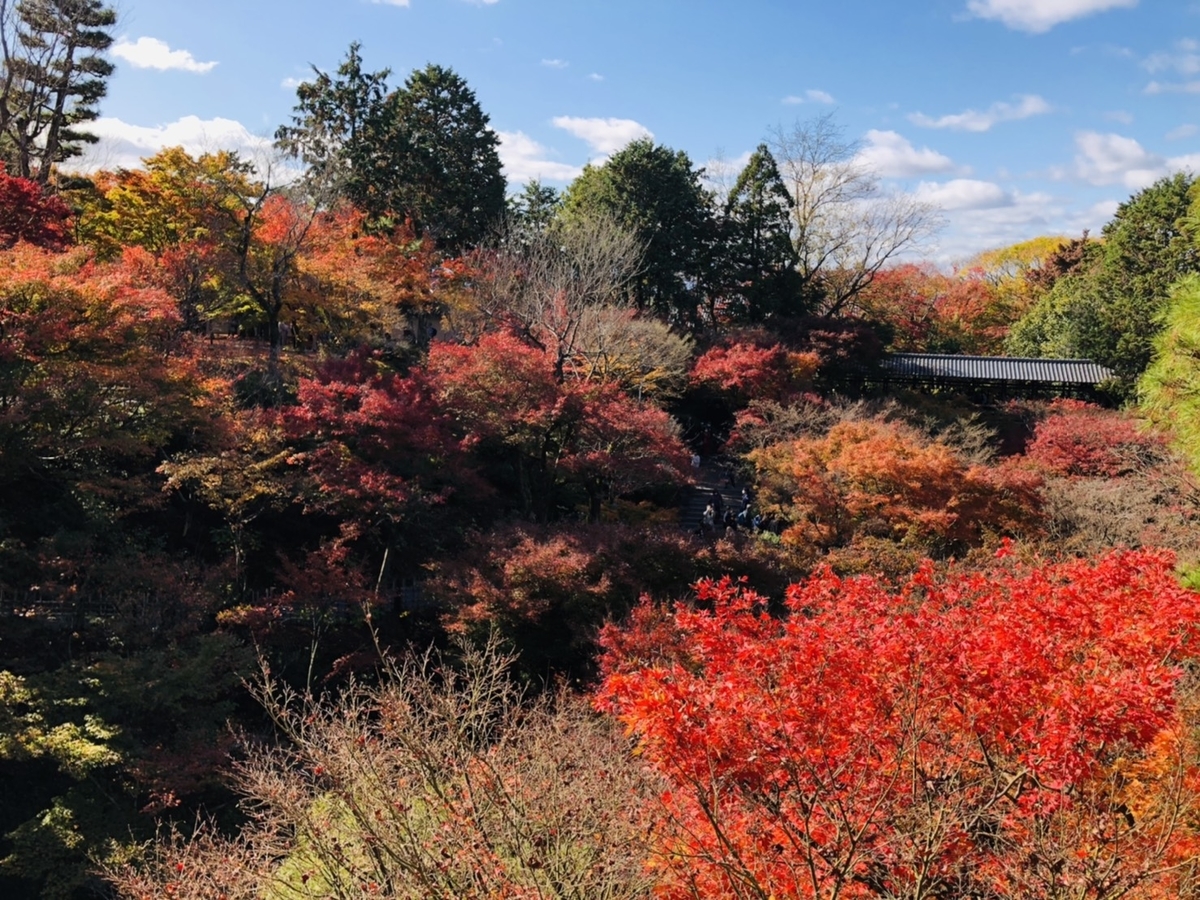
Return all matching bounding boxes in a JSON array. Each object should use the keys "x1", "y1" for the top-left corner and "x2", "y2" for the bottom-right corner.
[{"x1": 7, "y1": 15, "x2": 1200, "y2": 900}]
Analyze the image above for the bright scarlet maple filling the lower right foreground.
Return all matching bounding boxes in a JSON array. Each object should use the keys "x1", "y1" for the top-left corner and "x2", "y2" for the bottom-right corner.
[{"x1": 598, "y1": 552, "x2": 1200, "y2": 898}]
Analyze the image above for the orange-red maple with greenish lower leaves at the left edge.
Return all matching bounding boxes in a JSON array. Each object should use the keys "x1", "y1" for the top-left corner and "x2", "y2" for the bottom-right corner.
[{"x1": 0, "y1": 246, "x2": 205, "y2": 487}]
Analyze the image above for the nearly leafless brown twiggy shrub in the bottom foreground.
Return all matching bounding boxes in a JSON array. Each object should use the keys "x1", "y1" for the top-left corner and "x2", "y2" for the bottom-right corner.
[{"x1": 109, "y1": 648, "x2": 655, "y2": 900}]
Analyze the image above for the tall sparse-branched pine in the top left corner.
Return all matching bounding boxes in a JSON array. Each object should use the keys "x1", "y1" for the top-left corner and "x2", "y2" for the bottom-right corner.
[{"x1": 0, "y1": 0, "x2": 116, "y2": 185}]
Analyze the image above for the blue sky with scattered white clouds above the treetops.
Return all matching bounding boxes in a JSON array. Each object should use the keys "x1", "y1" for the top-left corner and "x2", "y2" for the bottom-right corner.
[{"x1": 79, "y1": 0, "x2": 1200, "y2": 263}]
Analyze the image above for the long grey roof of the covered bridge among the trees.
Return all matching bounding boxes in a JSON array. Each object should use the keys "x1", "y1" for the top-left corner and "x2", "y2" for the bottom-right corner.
[{"x1": 880, "y1": 353, "x2": 1115, "y2": 384}]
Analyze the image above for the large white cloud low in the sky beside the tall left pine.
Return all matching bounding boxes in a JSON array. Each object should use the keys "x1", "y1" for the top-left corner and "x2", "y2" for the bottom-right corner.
[{"x1": 72, "y1": 115, "x2": 272, "y2": 172}]
